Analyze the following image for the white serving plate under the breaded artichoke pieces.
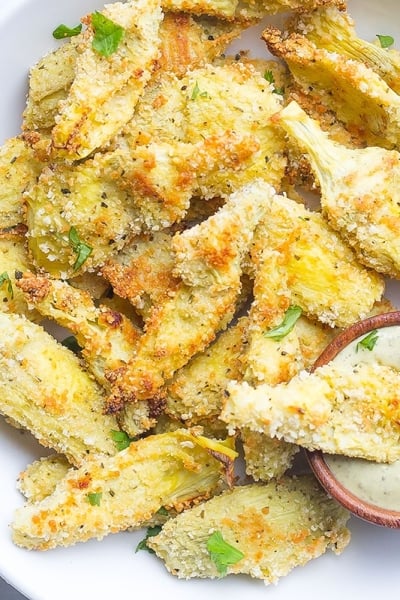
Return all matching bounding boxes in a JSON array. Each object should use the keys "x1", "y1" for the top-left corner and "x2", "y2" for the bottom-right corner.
[{"x1": 0, "y1": 0, "x2": 400, "y2": 600}]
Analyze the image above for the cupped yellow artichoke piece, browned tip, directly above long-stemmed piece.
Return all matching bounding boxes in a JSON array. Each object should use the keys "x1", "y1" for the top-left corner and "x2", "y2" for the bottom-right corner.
[{"x1": 263, "y1": 27, "x2": 400, "y2": 149}]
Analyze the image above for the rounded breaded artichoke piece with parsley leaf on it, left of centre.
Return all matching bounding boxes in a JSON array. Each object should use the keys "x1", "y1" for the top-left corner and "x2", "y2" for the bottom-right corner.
[{"x1": 25, "y1": 160, "x2": 141, "y2": 279}]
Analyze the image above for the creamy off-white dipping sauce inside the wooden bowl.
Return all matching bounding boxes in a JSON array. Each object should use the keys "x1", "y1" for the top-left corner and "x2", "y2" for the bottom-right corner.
[{"x1": 324, "y1": 325, "x2": 400, "y2": 511}]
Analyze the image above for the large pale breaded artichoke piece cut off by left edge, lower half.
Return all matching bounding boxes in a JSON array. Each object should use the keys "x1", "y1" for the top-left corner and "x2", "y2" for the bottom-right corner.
[{"x1": 0, "y1": 313, "x2": 119, "y2": 465}]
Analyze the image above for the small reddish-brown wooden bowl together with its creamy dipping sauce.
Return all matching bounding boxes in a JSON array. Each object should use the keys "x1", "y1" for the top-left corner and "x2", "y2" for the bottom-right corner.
[{"x1": 306, "y1": 311, "x2": 400, "y2": 529}]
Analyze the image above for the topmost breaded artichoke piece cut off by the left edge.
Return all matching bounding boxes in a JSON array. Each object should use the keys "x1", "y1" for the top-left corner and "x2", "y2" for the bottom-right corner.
[{"x1": 0, "y1": 137, "x2": 42, "y2": 231}]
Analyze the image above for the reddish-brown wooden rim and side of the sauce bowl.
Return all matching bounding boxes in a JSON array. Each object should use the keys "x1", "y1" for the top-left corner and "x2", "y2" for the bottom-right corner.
[{"x1": 306, "y1": 311, "x2": 400, "y2": 529}]
